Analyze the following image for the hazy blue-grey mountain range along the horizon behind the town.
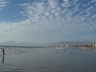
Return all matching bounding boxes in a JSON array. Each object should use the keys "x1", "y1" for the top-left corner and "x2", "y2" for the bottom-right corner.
[{"x1": 0, "y1": 40, "x2": 94, "y2": 46}]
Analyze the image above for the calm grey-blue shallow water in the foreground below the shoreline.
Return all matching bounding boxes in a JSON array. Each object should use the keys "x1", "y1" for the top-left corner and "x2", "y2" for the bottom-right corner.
[{"x1": 0, "y1": 48, "x2": 96, "y2": 72}]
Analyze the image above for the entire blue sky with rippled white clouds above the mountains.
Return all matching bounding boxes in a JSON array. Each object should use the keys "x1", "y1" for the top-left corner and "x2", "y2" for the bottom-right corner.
[{"x1": 0, "y1": 0, "x2": 96, "y2": 43}]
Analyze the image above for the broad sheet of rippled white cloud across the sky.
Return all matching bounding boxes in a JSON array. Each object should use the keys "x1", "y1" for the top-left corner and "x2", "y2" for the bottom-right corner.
[{"x1": 0, "y1": 0, "x2": 96, "y2": 42}]
